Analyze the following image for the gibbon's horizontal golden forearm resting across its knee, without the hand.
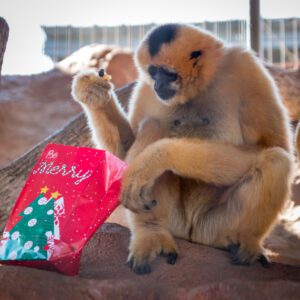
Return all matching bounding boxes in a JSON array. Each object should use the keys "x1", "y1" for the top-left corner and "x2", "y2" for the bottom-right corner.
[{"x1": 126, "y1": 139, "x2": 256, "y2": 186}]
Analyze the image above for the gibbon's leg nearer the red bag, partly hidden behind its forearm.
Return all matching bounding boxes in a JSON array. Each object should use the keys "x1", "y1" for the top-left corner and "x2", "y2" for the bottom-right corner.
[{"x1": 126, "y1": 118, "x2": 177, "y2": 274}]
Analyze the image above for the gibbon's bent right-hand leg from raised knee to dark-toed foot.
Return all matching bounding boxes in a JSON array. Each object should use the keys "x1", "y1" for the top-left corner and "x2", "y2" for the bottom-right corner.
[{"x1": 191, "y1": 147, "x2": 292, "y2": 266}]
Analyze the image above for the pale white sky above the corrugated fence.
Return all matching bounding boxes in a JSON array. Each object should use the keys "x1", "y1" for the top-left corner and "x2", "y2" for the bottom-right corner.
[{"x1": 0, "y1": 0, "x2": 300, "y2": 74}]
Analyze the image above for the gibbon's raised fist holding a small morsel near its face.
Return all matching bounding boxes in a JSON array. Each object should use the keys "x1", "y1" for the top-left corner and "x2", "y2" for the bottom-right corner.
[{"x1": 72, "y1": 71, "x2": 113, "y2": 108}]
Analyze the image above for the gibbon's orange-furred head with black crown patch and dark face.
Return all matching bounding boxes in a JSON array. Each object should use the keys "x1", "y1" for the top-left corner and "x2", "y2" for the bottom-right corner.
[{"x1": 135, "y1": 24, "x2": 224, "y2": 105}]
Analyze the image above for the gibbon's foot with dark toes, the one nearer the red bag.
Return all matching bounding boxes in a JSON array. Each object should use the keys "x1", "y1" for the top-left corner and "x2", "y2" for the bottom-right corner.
[{"x1": 127, "y1": 231, "x2": 178, "y2": 275}]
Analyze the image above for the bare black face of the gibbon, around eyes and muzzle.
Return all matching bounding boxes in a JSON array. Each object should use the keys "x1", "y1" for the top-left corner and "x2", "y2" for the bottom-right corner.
[{"x1": 148, "y1": 65, "x2": 178, "y2": 100}]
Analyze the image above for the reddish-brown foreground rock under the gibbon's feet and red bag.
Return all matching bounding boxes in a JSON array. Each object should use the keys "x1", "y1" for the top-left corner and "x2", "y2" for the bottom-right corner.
[{"x1": 0, "y1": 224, "x2": 300, "y2": 300}]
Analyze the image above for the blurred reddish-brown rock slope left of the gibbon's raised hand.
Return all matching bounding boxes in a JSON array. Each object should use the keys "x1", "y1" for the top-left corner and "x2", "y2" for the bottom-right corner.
[{"x1": 0, "y1": 70, "x2": 81, "y2": 168}]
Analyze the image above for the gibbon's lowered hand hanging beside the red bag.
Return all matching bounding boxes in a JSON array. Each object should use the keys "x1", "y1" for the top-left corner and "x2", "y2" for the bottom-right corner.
[{"x1": 120, "y1": 164, "x2": 157, "y2": 213}]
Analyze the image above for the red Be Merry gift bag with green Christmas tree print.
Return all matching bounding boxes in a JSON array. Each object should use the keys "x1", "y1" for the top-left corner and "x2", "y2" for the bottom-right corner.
[{"x1": 0, "y1": 144, "x2": 126, "y2": 275}]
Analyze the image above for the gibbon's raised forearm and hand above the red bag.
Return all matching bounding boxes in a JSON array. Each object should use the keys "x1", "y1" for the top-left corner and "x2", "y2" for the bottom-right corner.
[{"x1": 72, "y1": 71, "x2": 134, "y2": 159}]
